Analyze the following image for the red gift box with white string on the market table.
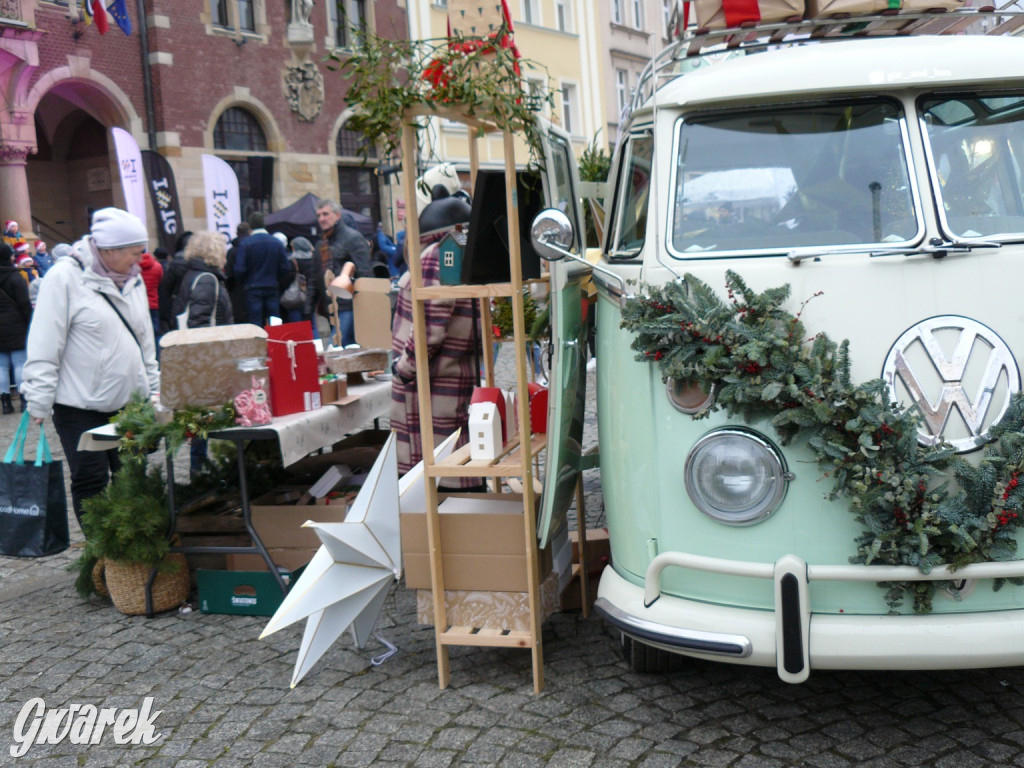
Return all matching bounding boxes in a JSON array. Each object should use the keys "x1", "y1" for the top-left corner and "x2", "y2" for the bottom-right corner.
[{"x1": 266, "y1": 321, "x2": 321, "y2": 416}]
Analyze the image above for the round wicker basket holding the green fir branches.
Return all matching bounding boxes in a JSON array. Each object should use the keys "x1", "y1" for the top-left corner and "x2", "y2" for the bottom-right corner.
[{"x1": 92, "y1": 553, "x2": 189, "y2": 616}]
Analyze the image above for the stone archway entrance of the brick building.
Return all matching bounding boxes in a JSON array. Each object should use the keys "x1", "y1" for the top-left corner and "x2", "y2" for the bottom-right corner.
[{"x1": 22, "y1": 71, "x2": 138, "y2": 247}]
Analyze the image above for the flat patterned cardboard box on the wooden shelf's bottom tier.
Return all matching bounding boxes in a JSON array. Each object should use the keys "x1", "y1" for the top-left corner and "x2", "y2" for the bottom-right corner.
[{"x1": 416, "y1": 573, "x2": 559, "y2": 631}]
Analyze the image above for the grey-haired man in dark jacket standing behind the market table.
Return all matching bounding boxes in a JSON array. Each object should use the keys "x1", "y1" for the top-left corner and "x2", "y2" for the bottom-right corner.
[{"x1": 314, "y1": 200, "x2": 374, "y2": 346}]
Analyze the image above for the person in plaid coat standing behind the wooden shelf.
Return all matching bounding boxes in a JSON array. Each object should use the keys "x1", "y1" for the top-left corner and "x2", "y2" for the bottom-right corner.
[{"x1": 391, "y1": 198, "x2": 482, "y2": 489}]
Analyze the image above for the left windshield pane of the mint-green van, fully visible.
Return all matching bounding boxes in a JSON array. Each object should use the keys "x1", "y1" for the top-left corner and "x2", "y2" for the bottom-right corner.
[{"x1": 672, "y1": 98, "x2": 921, "y2": 258}]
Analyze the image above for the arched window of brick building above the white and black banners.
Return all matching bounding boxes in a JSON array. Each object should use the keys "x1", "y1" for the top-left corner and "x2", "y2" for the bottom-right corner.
[{"x1": 213, "y1": 106, "x2": 273, "y2": 219}]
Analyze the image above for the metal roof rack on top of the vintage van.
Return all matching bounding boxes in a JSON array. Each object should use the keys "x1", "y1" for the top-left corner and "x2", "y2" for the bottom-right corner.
[{"x1": 630, "y1": 2, "x2": 1024, "y2": 112}]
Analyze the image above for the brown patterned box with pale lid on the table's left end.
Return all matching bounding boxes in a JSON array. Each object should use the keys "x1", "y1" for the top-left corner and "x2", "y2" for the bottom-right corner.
[{"x1": 160, "y1": 324, "x2": 268, "y2": 409}]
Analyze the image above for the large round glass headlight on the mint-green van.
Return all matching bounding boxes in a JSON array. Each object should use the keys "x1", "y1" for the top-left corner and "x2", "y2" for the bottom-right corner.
[{"x1": 685, "y1": 429, "x2": 793, "y2": 525}]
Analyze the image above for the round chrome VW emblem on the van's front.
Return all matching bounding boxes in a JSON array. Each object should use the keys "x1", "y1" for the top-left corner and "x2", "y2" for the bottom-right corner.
[{"x1": 882, "y1": 314, "x2": 1021, "y2": 454}]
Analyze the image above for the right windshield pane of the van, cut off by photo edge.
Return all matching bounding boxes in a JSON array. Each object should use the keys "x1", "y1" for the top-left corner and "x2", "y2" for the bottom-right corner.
[{"x1": 918, "y1": 92, "x2": 1024, "y2": 238}]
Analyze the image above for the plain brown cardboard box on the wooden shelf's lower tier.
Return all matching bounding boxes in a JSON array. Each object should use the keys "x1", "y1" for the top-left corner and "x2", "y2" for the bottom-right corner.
[{"x1": 399, "y1": 494, "x2": 551, "y2": 592}]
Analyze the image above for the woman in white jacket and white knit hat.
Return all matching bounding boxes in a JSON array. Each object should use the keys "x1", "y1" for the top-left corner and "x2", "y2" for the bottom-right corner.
[{"x1": 22, "y1": 208, "x2": 160, "y2": 523}]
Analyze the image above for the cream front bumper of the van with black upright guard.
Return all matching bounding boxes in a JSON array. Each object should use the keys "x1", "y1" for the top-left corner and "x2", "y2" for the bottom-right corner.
[{"x1": 594, "y1": 552, "x2": 1024, "y2": 683}]
